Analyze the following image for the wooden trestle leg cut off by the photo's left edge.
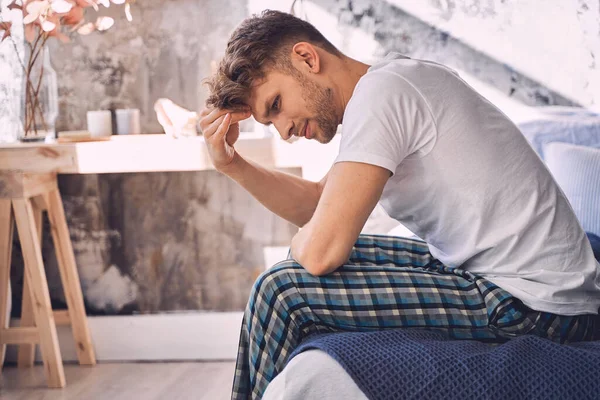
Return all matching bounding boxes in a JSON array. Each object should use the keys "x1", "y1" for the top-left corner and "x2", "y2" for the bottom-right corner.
[{"x1": 0, "y1": 199, "x2": 13, "y2": 370}]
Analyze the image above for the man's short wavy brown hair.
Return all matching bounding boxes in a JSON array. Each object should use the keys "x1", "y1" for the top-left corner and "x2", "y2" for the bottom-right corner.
[{"x1": 206, "y1": 10, "x2": 341, "y2": 110}]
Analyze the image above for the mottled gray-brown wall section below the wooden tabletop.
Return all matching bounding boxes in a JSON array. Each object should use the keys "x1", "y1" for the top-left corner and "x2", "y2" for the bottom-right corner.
[{"x1": 11, "y1": 170, "x2": 299, "y2": 314}]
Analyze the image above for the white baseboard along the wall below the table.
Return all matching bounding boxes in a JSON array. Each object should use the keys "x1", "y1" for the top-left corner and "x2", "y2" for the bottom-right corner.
[{"x1": 6, "y1": 312, "x2": 243, "y2": 363}]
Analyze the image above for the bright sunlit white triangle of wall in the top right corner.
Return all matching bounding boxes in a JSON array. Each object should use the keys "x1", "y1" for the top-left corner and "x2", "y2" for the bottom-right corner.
[{"x1": 386, "y1": 0, "x2": 600, "y2": 110}]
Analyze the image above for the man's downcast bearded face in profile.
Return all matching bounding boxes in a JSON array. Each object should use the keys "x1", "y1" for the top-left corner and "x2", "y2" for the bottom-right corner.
[{"x1": 250, "y1": 71, "x2": 340, "y2": 143}]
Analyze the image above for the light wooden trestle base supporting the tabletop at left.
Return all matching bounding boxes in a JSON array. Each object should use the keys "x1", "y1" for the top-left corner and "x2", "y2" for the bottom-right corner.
[{"x1": 0, "y1": 171, "x2": 96, "y2": 388}]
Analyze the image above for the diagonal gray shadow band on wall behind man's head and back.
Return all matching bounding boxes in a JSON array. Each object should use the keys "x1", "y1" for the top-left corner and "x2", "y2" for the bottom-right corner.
[{"x1": 305, "y1": 0, "x2": 581, "y2": 107}]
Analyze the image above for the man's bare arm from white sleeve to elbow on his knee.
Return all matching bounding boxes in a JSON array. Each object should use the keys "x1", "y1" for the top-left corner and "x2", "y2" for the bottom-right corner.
[{"x1": 292, "y1": 162, "x2": 391, "y2": 276}]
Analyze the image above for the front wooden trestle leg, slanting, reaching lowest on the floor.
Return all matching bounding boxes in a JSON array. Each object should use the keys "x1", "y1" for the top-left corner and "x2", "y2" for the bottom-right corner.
[{"x1": 13, "y1": 198, "x2": 65, "y2": 388}]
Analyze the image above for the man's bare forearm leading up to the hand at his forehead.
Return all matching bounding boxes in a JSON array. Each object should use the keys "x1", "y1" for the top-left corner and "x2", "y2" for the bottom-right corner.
[{"x1": 221, "y1": 153, "x2": 321, "y2": 227}]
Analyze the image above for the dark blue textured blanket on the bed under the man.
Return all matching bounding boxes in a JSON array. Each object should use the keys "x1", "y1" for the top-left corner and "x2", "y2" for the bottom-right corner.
[{"x1": 290, "y1": 329, "x2": 600, "y2": 400}]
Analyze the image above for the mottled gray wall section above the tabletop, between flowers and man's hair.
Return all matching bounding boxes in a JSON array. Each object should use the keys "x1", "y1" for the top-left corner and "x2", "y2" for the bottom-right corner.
[{"x1": 52, "y1": 0, "x2": 246, "y2": 133}]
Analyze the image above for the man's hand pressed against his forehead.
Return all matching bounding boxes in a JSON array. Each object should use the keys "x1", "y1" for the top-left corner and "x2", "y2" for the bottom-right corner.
[{"x1": 199, "y1": 108, "x2": 251, "y2": 170}]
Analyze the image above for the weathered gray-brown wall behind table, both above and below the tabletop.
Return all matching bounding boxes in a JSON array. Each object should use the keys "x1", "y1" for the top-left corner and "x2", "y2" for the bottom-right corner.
[{"x1": 6, "y1": 0, "x2": 299, "y2": 315}]
